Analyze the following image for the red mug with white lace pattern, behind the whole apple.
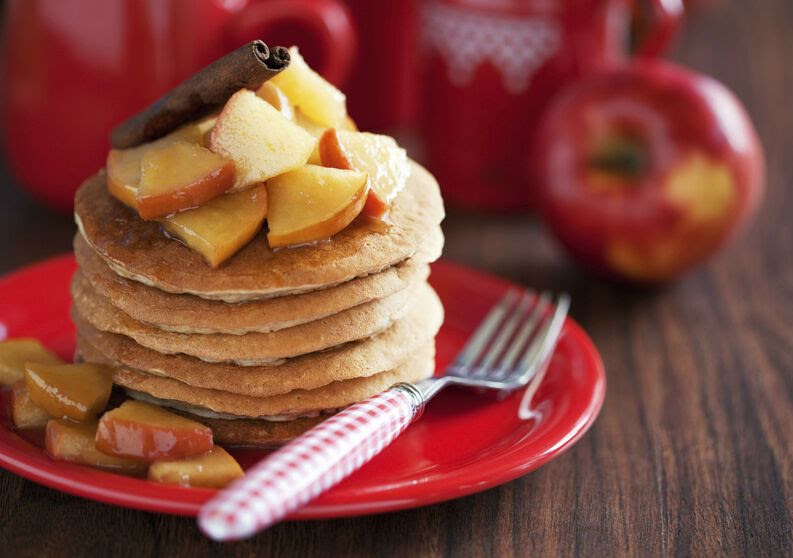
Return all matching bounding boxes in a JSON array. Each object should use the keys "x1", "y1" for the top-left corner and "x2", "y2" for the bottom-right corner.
[{"x1": 422, "y1": 0, "x2": 682, "y2": 211}]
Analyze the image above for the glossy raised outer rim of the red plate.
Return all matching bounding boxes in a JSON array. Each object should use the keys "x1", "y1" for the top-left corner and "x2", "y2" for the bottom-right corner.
[{"x1": 0, "y1": 254, "x2": 606, "y2": 519}]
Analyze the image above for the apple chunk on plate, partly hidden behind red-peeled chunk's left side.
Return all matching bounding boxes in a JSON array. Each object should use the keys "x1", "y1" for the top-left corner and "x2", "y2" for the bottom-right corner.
[{"x1": 44, "y1": 419, "x2": 147, "y2": 475}]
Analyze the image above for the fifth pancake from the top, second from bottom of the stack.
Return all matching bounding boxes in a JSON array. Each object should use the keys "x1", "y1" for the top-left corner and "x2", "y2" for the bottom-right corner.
[{"x1": 91, "y1": 343, "x2": 435, "y2": 418}]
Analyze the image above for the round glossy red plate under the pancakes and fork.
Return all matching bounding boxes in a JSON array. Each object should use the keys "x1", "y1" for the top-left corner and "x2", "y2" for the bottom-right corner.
[{"x1": 0, "y1": 255, "x2": 606, "y2": 518}]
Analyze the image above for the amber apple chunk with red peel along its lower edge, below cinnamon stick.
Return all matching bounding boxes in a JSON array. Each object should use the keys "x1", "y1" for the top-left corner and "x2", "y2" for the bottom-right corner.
[{"x1": 137, "y1": 141, "x2": 234, "y2": 220}]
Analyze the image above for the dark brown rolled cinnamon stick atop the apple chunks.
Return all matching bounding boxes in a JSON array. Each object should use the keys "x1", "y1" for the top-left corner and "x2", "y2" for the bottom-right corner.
[{"x1": 110, "y1": 41, "x2": 289, "y2": 149}]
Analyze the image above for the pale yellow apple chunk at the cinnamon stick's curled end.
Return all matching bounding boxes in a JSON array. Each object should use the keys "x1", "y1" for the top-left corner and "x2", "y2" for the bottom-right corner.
[{"x1": 270, "y1": 47, "x2": 347, "y2": 127}]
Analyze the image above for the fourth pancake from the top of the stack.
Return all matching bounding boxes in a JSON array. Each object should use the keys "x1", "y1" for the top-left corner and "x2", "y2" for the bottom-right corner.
[{"x1": 73, "y1": 289, "x2": 443, "y2": 397}]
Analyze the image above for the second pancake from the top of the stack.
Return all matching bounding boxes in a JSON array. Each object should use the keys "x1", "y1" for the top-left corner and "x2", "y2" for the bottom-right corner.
[{"x1": 74, "y1": 234, "x2": 429, "y2": 335}]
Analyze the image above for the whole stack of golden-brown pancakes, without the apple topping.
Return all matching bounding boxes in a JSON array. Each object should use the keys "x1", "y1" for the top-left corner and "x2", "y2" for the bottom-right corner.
[{"x1": 72, "y1": 164, "x2": 443, "y2": 446}]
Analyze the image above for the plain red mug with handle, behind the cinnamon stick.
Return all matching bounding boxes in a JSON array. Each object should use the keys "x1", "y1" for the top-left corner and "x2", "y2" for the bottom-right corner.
[{"x1": 0, "y1": 0, "x2": 355, "y2": 211}]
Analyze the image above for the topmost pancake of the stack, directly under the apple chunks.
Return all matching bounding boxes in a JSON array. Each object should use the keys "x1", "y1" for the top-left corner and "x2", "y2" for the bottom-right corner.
[{"x1": 75, "y1": 163, "x2": 444, "y2": 302}]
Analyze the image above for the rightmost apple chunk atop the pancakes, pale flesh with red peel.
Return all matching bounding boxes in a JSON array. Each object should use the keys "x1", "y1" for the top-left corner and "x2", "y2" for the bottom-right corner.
[{"x1": 319, "y1": 129, "x2": 410, "y2": 217}]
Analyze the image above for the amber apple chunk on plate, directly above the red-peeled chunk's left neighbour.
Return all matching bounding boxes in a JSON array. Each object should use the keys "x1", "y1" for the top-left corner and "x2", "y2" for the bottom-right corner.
[{"x1": 25, "y1": 362, "x2": 113, "y2": 421}]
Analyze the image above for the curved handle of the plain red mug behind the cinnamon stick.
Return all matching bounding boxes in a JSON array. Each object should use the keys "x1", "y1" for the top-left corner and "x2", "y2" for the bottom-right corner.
[{"x1": 228, "y1": 0, "x2": 357, "y2": 85}]
